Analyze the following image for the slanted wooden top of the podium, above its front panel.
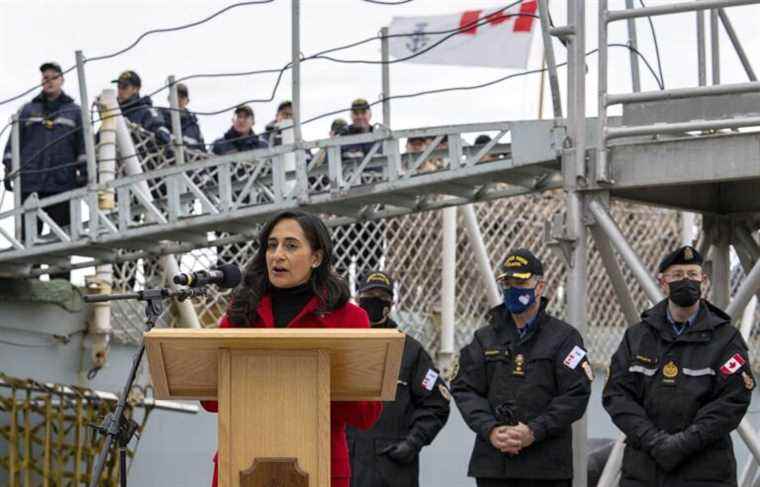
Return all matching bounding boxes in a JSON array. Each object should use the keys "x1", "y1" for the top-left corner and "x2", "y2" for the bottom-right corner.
[{"x1": 145, "y1": 328, "x2": 405, "y2": 401}]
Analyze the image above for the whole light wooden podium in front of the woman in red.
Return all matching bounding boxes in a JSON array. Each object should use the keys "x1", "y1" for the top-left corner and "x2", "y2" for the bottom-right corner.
[{"x1": 145, "y1": 328, "x2": 404, "y2": 487}]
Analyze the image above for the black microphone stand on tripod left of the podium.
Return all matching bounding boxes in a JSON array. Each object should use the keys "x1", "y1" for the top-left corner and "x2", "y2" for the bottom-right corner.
[{"x1": 84, "y1": 288, "x2": 206, "y2": 487}]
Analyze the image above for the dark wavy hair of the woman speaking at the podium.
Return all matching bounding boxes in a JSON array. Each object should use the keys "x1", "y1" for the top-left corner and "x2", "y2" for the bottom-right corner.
[{"x1": 227, "y1": 210, "x2": 351, "y2": 326}]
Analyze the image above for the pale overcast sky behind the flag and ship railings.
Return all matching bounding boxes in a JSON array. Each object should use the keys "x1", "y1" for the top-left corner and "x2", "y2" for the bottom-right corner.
[{"x1": 0, "y1": 0, "x2": 760, "y2": 282}]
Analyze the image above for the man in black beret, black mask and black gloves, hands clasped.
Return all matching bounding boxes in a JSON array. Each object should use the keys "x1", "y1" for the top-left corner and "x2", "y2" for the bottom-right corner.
[{"x1": 602, "y1": 246, "x2": 755, "y2": 487}]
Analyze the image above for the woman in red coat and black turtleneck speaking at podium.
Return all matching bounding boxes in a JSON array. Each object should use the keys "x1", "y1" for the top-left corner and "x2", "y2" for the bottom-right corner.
[{"x1": 202, "y1": 211, "x2": 382, "y2": 487}]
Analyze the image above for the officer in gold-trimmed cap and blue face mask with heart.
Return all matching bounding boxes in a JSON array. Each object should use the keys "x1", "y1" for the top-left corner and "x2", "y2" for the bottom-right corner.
[{"x1": 451, "y1": 249, "x2": 593, "y2": 487}]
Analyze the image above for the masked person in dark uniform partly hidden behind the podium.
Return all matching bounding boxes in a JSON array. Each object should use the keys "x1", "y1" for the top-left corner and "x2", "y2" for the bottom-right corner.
[{"x1": 346, "y1": 271, "x2": 450, "y2": 487}]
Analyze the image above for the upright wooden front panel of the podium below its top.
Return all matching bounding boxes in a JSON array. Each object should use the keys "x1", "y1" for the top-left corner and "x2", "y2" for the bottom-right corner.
[{"x1": 219, "y1": 350, "x2": 330, "y2": 487}]
